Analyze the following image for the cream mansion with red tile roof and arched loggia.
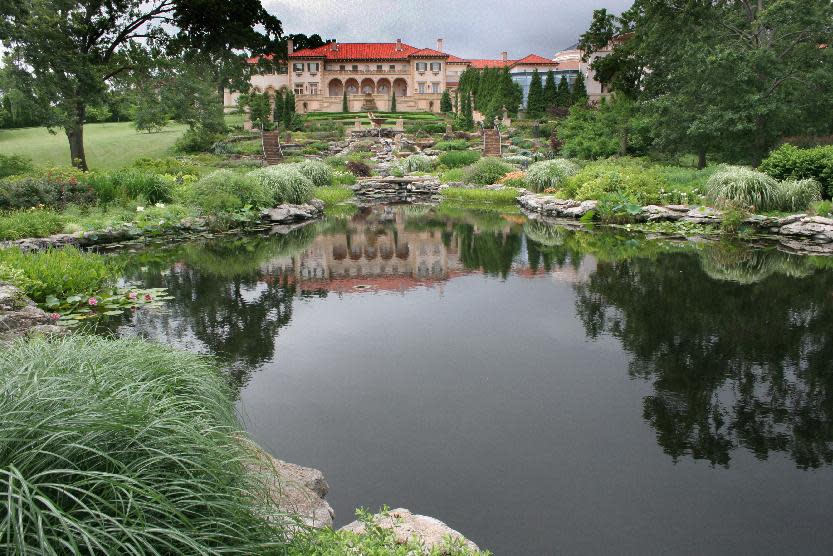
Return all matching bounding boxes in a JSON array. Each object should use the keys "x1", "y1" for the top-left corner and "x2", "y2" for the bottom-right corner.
[{"x1": 224, "y1": 39, "x2": 600, "y2": 114}]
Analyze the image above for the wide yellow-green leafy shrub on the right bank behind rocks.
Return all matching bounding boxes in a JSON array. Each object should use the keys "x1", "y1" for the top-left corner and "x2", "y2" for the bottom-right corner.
[{"x1": 559, "y1": 160, "x2": 665, "y2": 205}]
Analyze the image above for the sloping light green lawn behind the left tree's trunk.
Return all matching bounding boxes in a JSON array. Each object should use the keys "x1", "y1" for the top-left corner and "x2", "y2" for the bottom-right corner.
[{"x1": 0, "y1": 122, "x2": 186, "y2": 169}]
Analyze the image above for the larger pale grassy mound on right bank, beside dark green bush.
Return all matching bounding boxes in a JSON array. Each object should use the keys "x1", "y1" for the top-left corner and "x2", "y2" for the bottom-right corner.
[{"x1": 706, "y1": 166, "x2": 782, "y2": 211}]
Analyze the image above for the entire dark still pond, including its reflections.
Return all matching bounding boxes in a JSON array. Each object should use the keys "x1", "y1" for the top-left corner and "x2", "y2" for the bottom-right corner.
[{"x1": 115, "y1": 208, "x2": 833, "y2": 555}]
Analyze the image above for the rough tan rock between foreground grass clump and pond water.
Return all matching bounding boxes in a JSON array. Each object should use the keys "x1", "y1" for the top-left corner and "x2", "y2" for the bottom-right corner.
[{"x1": 250, "y1": 447, "x2": 335, "y2": 529}]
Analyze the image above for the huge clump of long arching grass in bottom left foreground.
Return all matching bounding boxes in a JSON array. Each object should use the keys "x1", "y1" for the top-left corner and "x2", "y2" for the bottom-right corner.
[{"x1": 0, "y1": 336, "x2": 287, "y2": 555}]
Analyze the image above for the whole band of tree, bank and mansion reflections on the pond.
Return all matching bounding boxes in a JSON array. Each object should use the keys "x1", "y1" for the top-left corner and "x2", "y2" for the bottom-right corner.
[{"x1": 115, "y1": 207, "x2": 833, "y2": 468}]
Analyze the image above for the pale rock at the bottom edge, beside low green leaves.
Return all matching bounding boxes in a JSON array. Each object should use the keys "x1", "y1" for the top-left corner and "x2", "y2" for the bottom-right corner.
[{"x1": 340, "y1": 508, "x2": 479, "y2": 554}]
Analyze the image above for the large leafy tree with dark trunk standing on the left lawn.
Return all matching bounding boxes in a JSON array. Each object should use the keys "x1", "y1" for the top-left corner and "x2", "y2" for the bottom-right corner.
[{"x1": 0, "y1": 0, "x2": 281, "y2": 170}]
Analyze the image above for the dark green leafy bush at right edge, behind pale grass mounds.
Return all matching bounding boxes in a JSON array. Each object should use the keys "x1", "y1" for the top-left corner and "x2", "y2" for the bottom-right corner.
[{"x1": 759, "y1": 144, "x2": 833, "y2": 196}]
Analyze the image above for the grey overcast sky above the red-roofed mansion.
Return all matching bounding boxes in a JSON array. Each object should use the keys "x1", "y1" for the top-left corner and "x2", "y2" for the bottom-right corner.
[{"x1": 263, "y1": 0, "x2": 632, "y2": 58}]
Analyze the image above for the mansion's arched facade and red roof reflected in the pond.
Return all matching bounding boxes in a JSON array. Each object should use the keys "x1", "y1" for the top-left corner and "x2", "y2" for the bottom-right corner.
[{"x1": 263, "y1": 211, "x2": 468, "y2": 292}]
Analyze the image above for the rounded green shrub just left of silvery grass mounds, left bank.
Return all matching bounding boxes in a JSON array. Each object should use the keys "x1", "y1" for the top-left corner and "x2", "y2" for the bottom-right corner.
[{"x1": 190, "y1": 170, "x2": 272, "y2": 213}]
